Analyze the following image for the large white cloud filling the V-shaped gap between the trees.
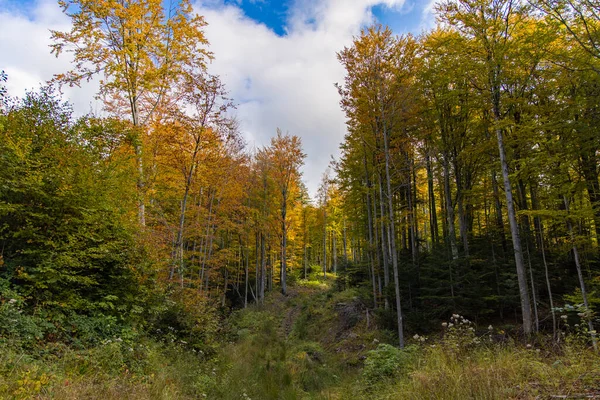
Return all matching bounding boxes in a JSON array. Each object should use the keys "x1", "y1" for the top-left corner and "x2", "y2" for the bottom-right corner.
[{"x1": 197, "y1": 0, "x2": 404, "y2": 195}]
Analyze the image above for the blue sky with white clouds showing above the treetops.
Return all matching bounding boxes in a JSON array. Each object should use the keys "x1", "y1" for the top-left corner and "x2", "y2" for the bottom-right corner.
[{"x1": 0, "y1": 0, "x2": 434, "y2": 195}]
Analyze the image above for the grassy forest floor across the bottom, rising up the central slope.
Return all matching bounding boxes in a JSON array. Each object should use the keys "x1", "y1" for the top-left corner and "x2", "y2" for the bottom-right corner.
[{"x1": 0, "y1": 278, "x2": 600, "y2": 400}]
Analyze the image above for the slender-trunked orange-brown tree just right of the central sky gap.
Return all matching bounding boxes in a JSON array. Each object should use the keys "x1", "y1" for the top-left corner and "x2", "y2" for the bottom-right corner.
[{"x1": 338, "y1": 26, "x2": 416, "y2": 347}]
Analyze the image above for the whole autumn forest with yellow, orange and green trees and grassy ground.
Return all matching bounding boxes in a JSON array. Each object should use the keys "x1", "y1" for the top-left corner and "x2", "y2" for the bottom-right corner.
[{"x1": 0, "y1": 0, "x2": 600, "y2": 399}]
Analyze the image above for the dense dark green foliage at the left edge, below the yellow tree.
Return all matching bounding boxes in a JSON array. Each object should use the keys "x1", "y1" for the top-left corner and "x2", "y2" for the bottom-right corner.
[{"x1": 0, "y1": 87, "x2": 143, "y2": 332}]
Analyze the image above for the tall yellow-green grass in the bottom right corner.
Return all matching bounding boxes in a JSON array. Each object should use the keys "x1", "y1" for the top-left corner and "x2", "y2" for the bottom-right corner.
[{"x1": 366, "y1": 346, "x2": 600, "y2": 399}]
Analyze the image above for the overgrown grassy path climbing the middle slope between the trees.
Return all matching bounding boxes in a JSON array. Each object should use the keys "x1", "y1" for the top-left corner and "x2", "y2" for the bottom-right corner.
[{"x1": 209, "y1": 278, "x2": 372, "y2": 400}]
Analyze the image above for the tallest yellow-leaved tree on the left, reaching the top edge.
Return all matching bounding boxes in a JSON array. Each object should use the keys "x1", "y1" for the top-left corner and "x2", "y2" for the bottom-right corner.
[{"x1": 51, "y1": 0, "x2": 211, "y2": 226}]
